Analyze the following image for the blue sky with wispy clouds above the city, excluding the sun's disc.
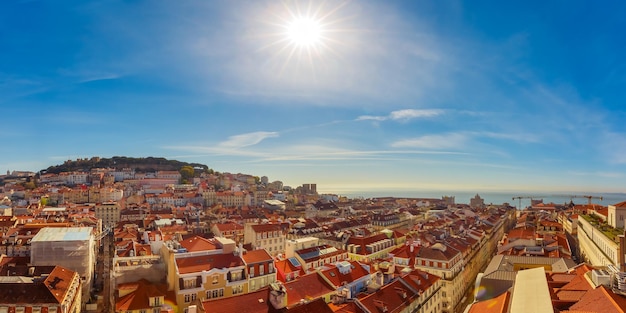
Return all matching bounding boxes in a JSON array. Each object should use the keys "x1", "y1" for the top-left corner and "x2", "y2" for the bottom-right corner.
[{"x1": 0, "y1": 0, "x2": 626, "y2": 193}]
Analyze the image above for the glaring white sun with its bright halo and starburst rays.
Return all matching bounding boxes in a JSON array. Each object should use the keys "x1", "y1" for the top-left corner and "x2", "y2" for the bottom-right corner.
[{"x1": 252, "y1": 0, "x2": 354, "y2": 76}]
